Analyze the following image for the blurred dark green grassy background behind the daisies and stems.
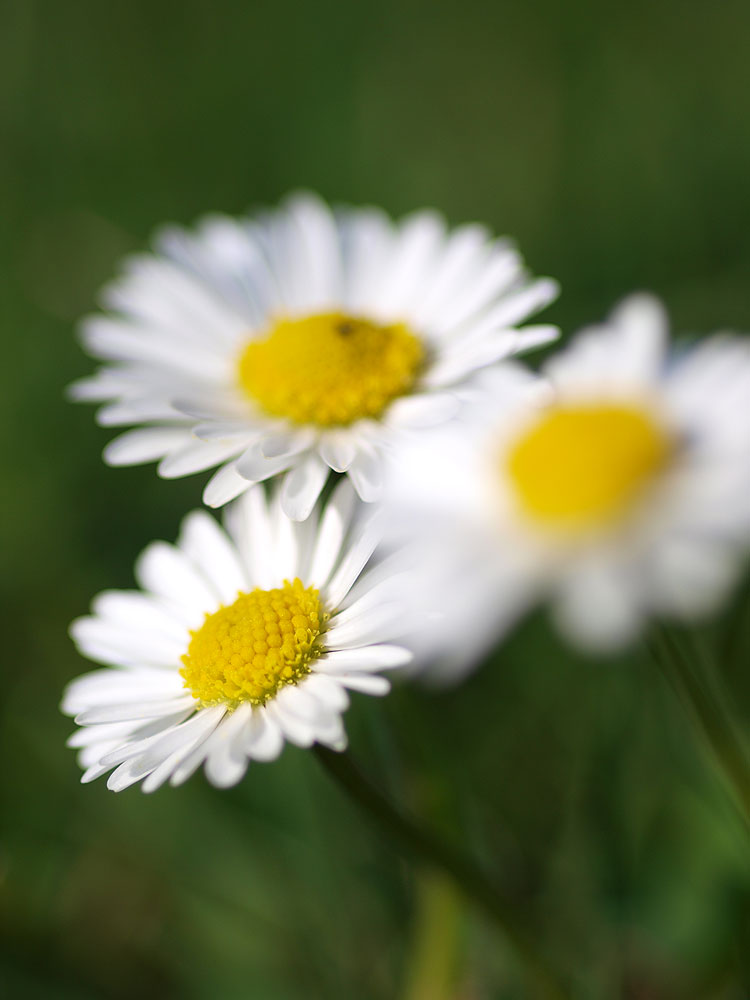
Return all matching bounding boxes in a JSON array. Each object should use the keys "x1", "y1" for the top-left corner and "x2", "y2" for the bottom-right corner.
[{"x1": 0, "y1": 0, "x2": 750, "y2": 1000}]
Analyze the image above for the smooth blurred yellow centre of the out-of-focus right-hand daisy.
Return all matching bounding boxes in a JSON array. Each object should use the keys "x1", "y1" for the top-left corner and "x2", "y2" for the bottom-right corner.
[{"x1": 506, "y1": 403, "x2": 673, "y2": 530}]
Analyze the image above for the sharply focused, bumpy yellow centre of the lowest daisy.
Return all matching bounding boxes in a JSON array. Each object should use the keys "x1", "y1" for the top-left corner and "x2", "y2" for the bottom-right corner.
[{"x1": 180, "y1": 580, "x2": 328, "y2": 709}]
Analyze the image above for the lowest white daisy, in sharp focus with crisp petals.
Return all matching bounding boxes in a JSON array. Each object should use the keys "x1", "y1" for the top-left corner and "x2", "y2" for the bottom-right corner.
[{"x1": 62, "y1": 480, "x2": 411, "y2": 791}]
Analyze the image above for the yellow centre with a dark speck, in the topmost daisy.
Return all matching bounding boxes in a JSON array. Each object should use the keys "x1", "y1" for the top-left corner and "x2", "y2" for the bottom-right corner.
[{"x1": 239, "y1": 312, "x2": 424, "y2": 427}]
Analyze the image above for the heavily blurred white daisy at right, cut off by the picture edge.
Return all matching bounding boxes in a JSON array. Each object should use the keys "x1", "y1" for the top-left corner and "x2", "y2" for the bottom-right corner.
[{"x1": 386, "y1": 295, "x2": 750, "y2": 676}]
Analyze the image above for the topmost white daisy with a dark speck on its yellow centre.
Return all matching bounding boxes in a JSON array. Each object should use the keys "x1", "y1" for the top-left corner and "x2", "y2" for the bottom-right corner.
[{"x1": 72, "y1": 188, "x2": 558, "y2": 520}]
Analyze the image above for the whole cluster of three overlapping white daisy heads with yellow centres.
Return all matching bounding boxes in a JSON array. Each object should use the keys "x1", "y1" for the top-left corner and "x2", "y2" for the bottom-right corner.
[{"x1": 62, "y1": 195, "x2": 750, "y2": 791}]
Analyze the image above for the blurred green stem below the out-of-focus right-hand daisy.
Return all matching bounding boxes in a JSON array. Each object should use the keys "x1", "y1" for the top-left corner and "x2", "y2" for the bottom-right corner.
[{"x1": 647, "y1": 627, "x2": 750, "y2": 828}]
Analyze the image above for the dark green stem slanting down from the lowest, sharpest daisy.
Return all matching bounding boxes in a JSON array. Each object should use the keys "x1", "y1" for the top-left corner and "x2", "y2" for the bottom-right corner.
[{"x1": 315, "y1": 746, "x2": 570, "y2": 1000}]
